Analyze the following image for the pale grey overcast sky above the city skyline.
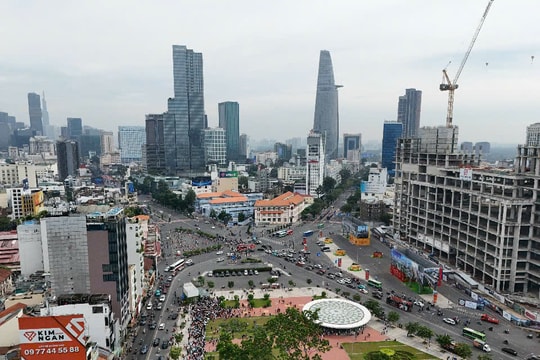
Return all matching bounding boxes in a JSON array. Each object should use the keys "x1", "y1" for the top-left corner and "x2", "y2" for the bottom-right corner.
[{"x1": 0, "y1": 0, "x2": 540, "y2": 144}]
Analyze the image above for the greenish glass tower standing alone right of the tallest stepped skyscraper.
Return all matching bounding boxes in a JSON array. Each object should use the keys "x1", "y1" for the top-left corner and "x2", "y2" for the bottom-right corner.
[{"x1": 218, "y1": 101, "x2": 240, "y2": 161}]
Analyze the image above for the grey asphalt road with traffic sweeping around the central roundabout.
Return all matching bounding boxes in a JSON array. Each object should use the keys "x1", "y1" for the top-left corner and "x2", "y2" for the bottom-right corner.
[{"x1": 132, "y1": 194, "x2": 537, "y2": 359}]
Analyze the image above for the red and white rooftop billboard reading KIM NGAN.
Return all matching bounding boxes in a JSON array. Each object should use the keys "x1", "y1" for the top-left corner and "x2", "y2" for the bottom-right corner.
[{"x1": 19, "y1": 315, "x2": 88, "y2": 360}]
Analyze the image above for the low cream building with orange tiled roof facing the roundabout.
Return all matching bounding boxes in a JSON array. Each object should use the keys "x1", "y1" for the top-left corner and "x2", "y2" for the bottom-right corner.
[{"x1": 254, "y1": 191, "x2": 309, "y2": 225}]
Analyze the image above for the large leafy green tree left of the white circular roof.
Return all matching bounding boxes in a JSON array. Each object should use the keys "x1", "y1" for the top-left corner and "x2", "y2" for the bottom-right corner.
[{"x1": 265, "y1": 307, "x2": 330, "y2": 360}]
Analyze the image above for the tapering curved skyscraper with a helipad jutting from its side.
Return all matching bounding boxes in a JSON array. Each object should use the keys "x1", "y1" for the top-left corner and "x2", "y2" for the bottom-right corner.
[{"x1": 313, "y1": 50, "x2": 341, "y2": 161}]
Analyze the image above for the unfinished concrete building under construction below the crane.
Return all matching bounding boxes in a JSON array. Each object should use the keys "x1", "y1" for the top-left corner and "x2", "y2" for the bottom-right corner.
[{"x1": 393, "y1": 126, "x2": 540, "y2": 296}]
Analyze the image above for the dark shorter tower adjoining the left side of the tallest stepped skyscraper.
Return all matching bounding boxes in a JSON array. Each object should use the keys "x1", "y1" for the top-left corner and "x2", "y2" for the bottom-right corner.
[{"x1": 145, "y1": 114, "x2": 165, "y2": 174}]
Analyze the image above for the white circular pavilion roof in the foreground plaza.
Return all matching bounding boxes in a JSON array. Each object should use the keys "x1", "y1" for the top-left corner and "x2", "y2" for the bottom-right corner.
[{"x1": 303, "y1": 299, "x2": 371, "y2": 329}]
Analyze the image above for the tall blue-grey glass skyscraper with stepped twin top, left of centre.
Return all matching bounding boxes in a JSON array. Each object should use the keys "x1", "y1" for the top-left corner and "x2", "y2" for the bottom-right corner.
[{"x1": 163, "y1": 45, "x2": 205, "y2": 174}]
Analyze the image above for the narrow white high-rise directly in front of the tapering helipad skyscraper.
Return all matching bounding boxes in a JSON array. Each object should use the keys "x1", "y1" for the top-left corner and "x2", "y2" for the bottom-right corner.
[{"x1": 306, "y1": 132, "x2": 325, "y2": 197}]
